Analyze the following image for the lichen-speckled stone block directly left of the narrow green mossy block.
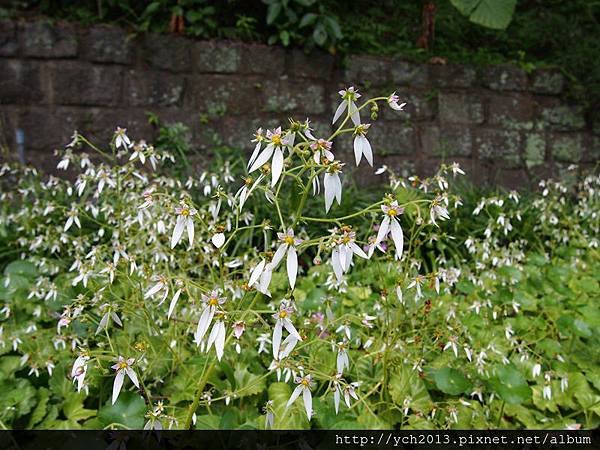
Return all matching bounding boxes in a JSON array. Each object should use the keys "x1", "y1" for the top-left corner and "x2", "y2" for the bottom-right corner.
[{"x1": 474, "y1": 128, "x2": 521, "y2": 167}]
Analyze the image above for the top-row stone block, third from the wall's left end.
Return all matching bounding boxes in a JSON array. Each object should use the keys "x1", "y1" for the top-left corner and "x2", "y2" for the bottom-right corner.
[{"x1": 82, "y1": 26, "x2": 131, "y2": 64}]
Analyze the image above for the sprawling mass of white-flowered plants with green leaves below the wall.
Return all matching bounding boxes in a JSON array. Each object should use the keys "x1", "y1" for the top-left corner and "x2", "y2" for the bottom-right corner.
[{"x1": 0, "y1": 87, "x2": 598, "y2": 429}]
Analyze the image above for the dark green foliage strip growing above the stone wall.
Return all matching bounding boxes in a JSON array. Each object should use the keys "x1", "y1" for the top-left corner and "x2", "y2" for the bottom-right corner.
[{"x1": 0, "y1": 0, "x2": 600, "y2": 110}]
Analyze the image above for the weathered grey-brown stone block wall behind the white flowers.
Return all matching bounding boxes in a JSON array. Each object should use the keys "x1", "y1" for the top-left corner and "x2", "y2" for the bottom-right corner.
[{"x1": 0, "y1": 21, "x2": 600, "y2": 187}]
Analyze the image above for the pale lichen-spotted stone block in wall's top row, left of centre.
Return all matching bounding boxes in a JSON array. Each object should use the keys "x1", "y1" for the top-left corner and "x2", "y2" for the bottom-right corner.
[{"x1": 192, "y1": 41, "x2": 242, "y2": 73}]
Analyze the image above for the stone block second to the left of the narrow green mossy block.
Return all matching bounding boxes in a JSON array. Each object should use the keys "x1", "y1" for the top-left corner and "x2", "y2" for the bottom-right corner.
[{"x1": 421, "y1": 126, "x2": 473, "y2": 158}]
